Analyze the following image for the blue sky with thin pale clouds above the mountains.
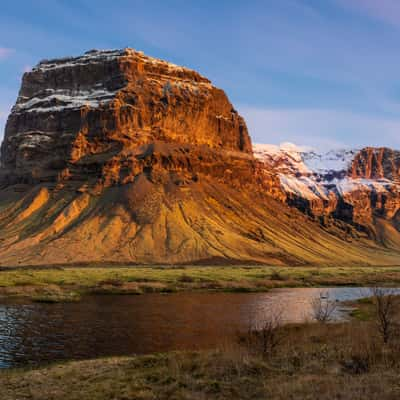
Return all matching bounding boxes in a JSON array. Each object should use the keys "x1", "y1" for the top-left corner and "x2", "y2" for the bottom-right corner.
[{"x1": 0, "y1": 0, "x2": 400, "y2": 149}]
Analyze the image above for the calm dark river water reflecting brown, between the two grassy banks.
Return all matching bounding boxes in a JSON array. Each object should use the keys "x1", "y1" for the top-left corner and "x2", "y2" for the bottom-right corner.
[{"x1": 0, "y1": 288, "x2": 388, "y2": 368}]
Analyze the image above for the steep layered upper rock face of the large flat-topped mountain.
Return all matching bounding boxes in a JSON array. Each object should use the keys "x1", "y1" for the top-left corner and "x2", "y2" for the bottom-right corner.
[{"x1": 1, "y1": 49, "x2": 252, "y2": 183}]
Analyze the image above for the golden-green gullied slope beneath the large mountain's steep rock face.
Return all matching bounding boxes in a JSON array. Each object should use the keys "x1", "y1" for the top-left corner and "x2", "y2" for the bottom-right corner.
[{"x1": 0, "y1": 178, "x2": 400, "y2": 266}]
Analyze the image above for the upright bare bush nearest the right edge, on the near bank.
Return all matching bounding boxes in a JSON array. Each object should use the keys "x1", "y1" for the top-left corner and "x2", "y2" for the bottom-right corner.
[{"x1": 371, "y1": 287, "x2": 395, "y2": 344}]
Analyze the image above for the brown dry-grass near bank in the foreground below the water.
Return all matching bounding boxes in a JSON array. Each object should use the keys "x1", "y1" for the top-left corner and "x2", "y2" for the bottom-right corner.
[{"x1": 0, "y1": 314, "x2": 400, "y2": 400}]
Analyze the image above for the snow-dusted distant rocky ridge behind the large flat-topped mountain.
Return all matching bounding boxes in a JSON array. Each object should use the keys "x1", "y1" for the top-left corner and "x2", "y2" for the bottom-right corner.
[{"x1": 254, "y1": 144, "x2": 400, "y2": 237}]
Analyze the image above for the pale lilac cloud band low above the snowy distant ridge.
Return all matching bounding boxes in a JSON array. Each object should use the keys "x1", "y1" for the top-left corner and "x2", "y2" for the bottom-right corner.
[{"x1": 239, "y1": 107, "x2": 400, "y2": 149}]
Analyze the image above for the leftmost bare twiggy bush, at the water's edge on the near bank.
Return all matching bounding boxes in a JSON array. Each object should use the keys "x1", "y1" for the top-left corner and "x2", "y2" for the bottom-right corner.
[{"x1": 239, "y1": 307, "x2": 284, "y2": 357}]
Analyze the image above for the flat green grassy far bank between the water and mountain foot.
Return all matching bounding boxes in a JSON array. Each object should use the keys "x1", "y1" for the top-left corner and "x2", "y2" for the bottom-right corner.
[{"x1": 0, "y1": 266, "x2": 400, "y2": 302}]
